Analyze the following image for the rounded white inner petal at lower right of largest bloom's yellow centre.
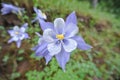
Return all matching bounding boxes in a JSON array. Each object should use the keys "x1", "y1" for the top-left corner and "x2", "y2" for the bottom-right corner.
[{"x1": 63, "y1": 39, "x2": 77, "y2": 52}]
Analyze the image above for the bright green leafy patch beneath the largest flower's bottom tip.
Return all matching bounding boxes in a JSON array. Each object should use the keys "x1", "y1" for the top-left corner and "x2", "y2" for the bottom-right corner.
[{"x1": 26, "y1": 58, "x2": 102, "y2": 80}]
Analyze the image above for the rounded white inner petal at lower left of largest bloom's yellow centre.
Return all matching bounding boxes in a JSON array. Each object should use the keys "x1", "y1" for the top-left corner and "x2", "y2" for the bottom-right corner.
[{"x1": 47, "y1": 43, "x2": 61, "y2": 56}]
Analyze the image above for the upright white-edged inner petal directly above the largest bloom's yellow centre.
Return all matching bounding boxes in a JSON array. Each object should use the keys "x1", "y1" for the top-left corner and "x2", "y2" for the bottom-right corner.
[{"x1": 54, "y1": 18, "x2": 65, "y2": 34}]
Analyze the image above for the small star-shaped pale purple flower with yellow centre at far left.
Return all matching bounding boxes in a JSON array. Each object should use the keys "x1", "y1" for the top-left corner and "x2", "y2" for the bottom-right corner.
[{"x1": 8, "y1": 23, "x2": 29, "y2": 48}]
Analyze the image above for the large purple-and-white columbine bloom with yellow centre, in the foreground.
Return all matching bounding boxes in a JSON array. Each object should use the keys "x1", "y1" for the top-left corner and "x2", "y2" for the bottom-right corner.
[{"x1": 34, "y1": 12, "x2": 92, "y2": 70}]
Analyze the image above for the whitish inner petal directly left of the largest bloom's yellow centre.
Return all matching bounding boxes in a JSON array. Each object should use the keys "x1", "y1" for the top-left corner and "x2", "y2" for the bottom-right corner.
[{"x1": 43, "y1": 29, "x2": 55, "y2": 43}]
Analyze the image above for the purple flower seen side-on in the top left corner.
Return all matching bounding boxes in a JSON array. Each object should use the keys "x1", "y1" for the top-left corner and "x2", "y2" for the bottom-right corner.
[{"x1": 1, "y1": 3, "x2": 24, "y2": 15}]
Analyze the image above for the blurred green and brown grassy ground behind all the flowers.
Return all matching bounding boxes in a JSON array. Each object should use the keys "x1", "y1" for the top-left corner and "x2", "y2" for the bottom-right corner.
[{"x1": 0, "y1": 0, "x2": 120, "y2": 80}]
